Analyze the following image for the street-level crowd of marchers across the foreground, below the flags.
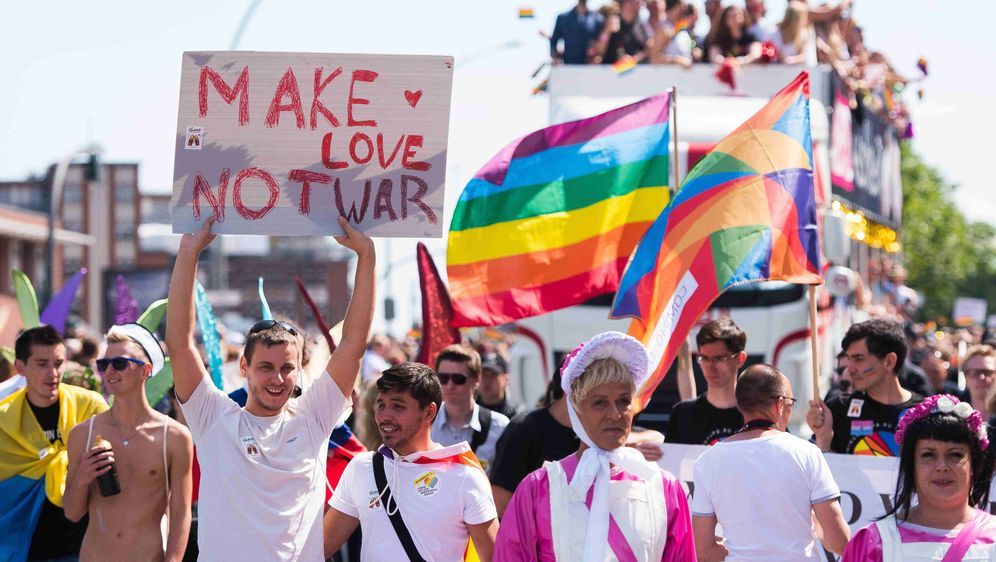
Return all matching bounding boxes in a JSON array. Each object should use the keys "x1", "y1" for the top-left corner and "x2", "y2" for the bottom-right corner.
[{"x1": 0, "y1": 233, "x2": 996, "y2": 562}]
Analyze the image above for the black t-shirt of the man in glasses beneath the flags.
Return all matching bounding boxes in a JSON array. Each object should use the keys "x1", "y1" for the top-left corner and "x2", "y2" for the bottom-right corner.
[{"x1": 664, "y1": 392, "x2": 744, "y2": 445}]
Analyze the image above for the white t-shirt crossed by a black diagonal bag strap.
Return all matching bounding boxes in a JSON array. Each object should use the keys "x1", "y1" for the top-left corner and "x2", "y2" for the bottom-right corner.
[{"x1": 329, "y1": 444, "x2": 498, "y2": 562}]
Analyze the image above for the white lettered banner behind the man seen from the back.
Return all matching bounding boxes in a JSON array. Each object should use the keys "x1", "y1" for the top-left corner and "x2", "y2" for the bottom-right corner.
[{"x1": 657, "y1": 443, "x2": 996, "y2": 560}]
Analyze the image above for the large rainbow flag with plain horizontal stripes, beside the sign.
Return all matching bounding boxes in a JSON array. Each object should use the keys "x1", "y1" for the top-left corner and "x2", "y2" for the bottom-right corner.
[{"x1": 446, "y1": 94, "x2": 669, "y2": 326}]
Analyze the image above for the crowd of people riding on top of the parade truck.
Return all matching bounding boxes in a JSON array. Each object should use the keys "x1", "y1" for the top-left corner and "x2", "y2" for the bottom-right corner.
[{"x1": 550, "y1": 0, "x2": 927, "y2": 137}]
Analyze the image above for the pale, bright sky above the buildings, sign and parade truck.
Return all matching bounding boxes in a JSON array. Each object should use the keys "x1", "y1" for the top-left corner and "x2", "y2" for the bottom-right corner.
[{"x1": 0, "y1": 0, "x2": 996, "y2": 328}]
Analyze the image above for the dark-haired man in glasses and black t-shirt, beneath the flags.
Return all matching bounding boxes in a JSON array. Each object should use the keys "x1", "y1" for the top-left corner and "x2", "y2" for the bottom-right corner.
[{"x1": 664, "y1": 317, "x2": 747, "y2": 445}]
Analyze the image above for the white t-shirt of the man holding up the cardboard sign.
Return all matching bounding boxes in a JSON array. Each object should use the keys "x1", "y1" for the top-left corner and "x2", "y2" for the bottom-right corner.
[{"x1": 180, "y1": 374, "x2": 346, "y2": 561}]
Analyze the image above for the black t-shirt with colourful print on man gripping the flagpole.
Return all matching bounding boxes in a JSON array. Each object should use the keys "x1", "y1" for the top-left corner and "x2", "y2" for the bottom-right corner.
[{"x1": 827, "y1": 392, "x2": 923, "y2": 457}]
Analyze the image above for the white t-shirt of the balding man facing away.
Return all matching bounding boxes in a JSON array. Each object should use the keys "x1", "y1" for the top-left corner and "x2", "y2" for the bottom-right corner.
[{"x1": 692, "y1": 432, "x2": 840, "y2": 562}]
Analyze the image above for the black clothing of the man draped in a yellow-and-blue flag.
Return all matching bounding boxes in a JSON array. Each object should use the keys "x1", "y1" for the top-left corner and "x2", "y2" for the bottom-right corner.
[{"x1": 28, "y1": 400, "x2": 87, "y2": 560}]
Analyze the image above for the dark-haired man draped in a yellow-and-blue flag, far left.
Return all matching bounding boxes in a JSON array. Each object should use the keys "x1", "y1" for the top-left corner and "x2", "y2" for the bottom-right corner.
[{"x1": 0, "y1": 326, "x2": 107, "y2": 560}]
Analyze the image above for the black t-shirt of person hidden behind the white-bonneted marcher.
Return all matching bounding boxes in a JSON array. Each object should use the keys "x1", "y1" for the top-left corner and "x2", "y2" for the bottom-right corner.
[{"x1": 491, "y1": 402, "x2": 581, "y2": 492}]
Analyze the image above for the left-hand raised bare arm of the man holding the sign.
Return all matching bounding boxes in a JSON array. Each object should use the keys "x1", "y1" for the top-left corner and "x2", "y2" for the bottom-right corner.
[{"x1": 166, "y1": 217, "x2": 215, "y2": 403}]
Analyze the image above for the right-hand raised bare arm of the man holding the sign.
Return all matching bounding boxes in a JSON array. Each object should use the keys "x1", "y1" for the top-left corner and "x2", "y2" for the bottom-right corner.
[{"x1": 322, "y1": 217, "x2": 377, "y2": 396}]
